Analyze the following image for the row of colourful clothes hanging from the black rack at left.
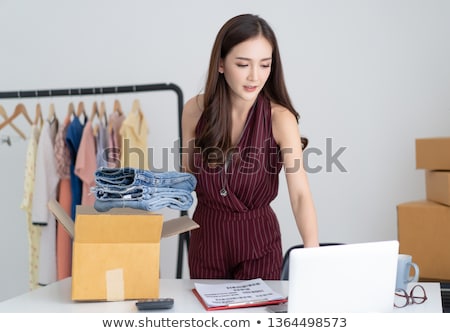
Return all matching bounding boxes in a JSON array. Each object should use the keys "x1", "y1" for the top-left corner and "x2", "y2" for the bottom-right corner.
[{"x1": 16, "y1": 99, "x2": 163, "y2": 289}]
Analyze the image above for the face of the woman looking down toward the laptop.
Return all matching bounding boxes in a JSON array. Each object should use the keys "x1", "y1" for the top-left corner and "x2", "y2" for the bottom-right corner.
[{"x1": 219, "y1": 36, "x2": 272, "y2": 102}]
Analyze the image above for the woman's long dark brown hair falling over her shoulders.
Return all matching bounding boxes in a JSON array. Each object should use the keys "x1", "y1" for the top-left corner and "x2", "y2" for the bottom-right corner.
[{"x1": 196, "y1": 14, "x2": 308, "y2": 160}]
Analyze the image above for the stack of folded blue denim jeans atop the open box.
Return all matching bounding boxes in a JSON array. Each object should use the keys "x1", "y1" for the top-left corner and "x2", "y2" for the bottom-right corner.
[{"x1": 91, "y1": 167, "x2": 197, "y2": 212}]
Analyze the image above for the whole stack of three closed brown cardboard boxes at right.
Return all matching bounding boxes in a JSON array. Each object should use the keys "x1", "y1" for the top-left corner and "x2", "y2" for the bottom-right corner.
[{"x1": 397, "y1": 137, "x2": 450, "y2": 281}]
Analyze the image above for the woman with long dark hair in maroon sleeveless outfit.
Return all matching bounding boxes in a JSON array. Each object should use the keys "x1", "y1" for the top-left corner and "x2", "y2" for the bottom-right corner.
[{"x1": 182, "y1": 14, "x2": 318, "y2": 280}]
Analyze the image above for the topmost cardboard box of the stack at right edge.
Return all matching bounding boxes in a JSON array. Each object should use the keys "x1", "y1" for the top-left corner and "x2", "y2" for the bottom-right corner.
[{"x1": 416, "y1": 137, "x2": 450, "y2": 170}]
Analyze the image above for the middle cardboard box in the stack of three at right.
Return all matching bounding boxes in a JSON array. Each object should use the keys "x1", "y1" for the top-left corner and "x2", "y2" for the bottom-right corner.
[{"x1": 425, "y1": 170, "x2": 450, "y2": 206}]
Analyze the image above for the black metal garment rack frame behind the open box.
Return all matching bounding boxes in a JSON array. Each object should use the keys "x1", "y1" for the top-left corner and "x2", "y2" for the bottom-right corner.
[{"x1": 0, "y1": 83, "x2": 190, "y2": 279}]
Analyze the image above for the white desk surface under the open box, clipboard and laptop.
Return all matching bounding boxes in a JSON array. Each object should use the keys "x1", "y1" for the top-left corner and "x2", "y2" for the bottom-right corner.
[{"x1": 0, "y1": 278, "x2": 442, "y2": 313}]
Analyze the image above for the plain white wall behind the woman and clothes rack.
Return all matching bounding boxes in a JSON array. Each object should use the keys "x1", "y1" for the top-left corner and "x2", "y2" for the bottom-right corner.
[{"x1": 0, "y1": 0, "x2": 450, "y2": 300}]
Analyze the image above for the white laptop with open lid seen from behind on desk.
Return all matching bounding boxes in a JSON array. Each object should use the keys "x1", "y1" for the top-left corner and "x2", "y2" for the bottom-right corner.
[{"x1": 287, "y1": 240, "x2": 399, "y2": 313}]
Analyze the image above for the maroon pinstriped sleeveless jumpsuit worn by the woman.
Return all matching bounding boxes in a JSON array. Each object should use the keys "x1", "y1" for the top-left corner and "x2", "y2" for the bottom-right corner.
[{"x1": 189, "y1": 94, "x2": 282, "y2": 280}]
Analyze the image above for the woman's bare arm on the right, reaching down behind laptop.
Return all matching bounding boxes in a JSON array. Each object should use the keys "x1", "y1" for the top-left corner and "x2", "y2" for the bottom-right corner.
[{"x1": 272, "y1": 105, "x2": 319, "y2": 247}]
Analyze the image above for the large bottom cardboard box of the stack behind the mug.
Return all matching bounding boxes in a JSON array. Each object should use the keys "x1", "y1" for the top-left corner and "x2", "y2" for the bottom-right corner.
[{"x1": 397, "y1": 201, "x2": 450, "y2": 281}]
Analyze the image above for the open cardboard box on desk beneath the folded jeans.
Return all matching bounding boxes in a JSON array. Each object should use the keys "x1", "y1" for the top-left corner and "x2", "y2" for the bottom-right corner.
[{"x1": 49, "y1": 200, "x2": 198, "y2": 301}]
